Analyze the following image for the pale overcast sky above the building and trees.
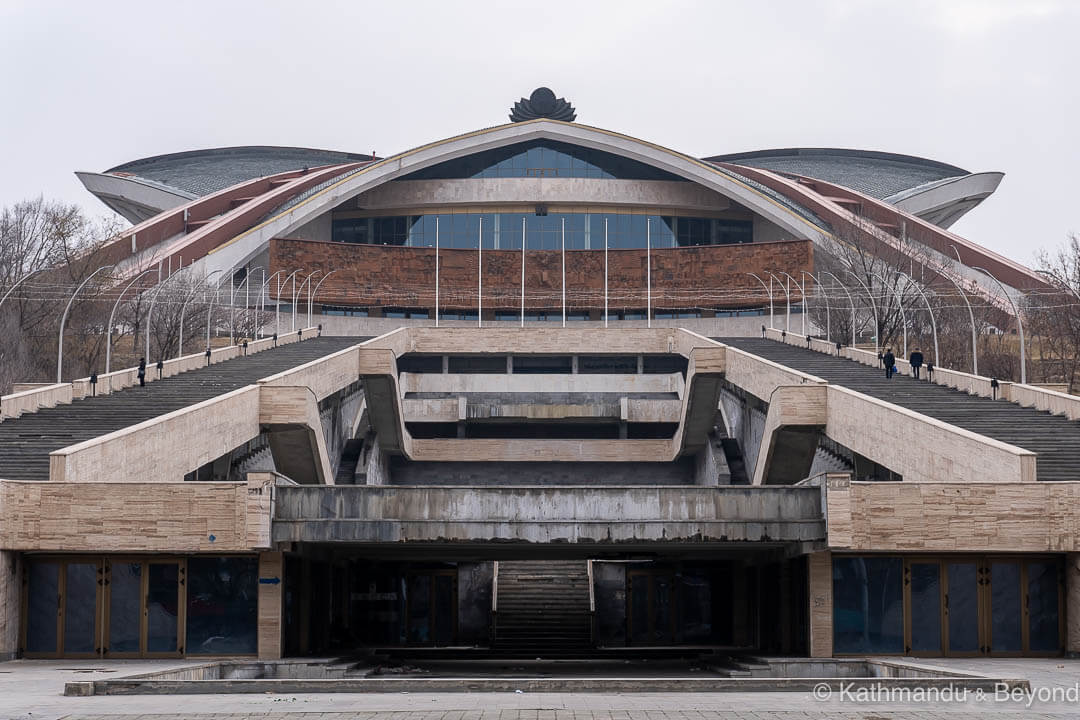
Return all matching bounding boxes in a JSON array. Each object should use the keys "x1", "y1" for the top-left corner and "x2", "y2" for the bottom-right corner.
[{"x1": 0, "y1": 0, "x2": 1080, "y2": 262}]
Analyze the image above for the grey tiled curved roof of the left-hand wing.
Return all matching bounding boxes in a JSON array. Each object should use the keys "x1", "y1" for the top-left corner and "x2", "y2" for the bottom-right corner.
[{"x1": 106, "y1": 146, "x2": 372, "y2": 196}]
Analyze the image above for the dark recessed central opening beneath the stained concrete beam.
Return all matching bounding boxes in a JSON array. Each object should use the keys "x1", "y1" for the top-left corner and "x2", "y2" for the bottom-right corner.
[{"x1": 283, "y1": 545, "x2": 808, "y2": 656}]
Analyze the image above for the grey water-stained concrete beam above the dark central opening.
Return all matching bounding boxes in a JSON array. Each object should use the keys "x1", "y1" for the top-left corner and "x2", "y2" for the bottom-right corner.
[{"x1": 273, "y1": 486, "x2": 825, "y2": 543}]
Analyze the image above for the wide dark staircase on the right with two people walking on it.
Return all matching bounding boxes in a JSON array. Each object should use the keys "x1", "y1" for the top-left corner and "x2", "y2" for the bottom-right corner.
[{"x1": 715, "y1": 338, "x2": 1080, "y2": 481}]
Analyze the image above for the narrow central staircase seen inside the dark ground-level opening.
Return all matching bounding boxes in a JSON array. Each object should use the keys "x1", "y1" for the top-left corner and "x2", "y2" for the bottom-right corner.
[{"x1": 495, "y1": 560, "x2": 592, "y2": 654}]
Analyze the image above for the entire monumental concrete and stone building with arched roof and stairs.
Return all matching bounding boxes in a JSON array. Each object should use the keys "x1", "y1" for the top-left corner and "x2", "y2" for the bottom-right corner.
[{"x1": 0, "y1": 89, "x2": 1080, "y2": 658}]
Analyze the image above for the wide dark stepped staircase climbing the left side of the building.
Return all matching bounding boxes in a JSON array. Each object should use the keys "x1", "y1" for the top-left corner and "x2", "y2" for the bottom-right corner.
[{"x1": 0, "y1": 337, "x2": 366, "y2": 480}]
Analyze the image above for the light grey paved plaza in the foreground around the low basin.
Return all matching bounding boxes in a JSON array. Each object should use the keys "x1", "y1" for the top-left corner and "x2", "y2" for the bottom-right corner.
[{"x1": 0, "y1": 658, "x2": 1080, "y2": 720}]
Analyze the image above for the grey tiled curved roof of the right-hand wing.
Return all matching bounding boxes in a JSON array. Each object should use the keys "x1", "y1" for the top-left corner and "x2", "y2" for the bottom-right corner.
[{"x1": 705, "y1": 148, "x2": 970, "y2": 200}]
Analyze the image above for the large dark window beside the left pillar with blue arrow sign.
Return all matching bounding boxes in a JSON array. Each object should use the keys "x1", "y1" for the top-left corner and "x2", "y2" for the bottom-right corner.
[{"x1": 187, "y1": 557, "x2": 258, "y2": 655}]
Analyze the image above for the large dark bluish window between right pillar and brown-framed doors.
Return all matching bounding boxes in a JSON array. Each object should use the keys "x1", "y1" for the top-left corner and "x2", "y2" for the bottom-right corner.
[{"x1": 833, "y1": 557, "x2": 904, "y2": 653}]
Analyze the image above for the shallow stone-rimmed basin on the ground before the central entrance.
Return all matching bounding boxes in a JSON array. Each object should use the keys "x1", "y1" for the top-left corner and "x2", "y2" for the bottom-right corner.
[{"x1": 64, "y1": 656, "x2": 1030, "y2": 695}]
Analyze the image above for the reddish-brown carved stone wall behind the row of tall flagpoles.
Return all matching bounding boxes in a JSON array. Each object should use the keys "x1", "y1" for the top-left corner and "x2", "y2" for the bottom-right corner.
[{"x1": 270, "y1": 239, "x2": 813, "y2": 311}]
